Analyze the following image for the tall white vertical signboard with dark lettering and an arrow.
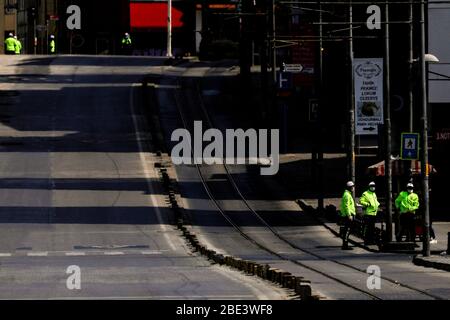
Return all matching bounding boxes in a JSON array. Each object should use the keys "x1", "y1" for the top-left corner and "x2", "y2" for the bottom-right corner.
[{"x1": 353, "y1": 58, "x2": 383, "y2": 135}]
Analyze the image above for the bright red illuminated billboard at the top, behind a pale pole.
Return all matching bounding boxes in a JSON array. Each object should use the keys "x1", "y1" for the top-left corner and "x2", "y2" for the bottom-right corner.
[{"x1": 130, "y1": 2, "x2": 183, "y2": 29}]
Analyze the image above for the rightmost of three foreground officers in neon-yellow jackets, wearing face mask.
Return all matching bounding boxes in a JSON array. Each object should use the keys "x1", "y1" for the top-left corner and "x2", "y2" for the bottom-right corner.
[{"x1": 395, "y1": 183, "x2": 419, "y2": 242}]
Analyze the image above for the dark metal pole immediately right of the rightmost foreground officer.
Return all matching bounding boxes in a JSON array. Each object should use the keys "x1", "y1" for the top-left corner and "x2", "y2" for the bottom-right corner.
[{"x1": 420, "y1": 3, "x2": 430, "y2": 257}]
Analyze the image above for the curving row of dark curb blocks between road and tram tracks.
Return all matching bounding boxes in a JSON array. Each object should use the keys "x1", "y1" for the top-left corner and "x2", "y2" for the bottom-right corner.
[{"x1": 144, "y1": 77, "x2": 318, "y2": 300}]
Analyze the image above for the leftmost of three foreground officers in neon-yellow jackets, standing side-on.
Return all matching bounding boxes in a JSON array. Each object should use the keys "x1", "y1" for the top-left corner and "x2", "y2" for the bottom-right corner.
[{"x1": 339, "y1": 181, "x2": 356, "y2": 250}]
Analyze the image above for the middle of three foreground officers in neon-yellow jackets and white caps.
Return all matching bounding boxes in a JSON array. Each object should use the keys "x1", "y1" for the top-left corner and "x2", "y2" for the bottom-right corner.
[{"x1": 359, "y1": 181, "x2": 380, "y2": 245}]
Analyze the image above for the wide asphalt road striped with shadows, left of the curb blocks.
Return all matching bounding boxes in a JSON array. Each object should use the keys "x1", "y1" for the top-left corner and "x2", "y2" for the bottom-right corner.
[{"x1": 0, "y1": 56, "x2": 289, "y2": 299}]
